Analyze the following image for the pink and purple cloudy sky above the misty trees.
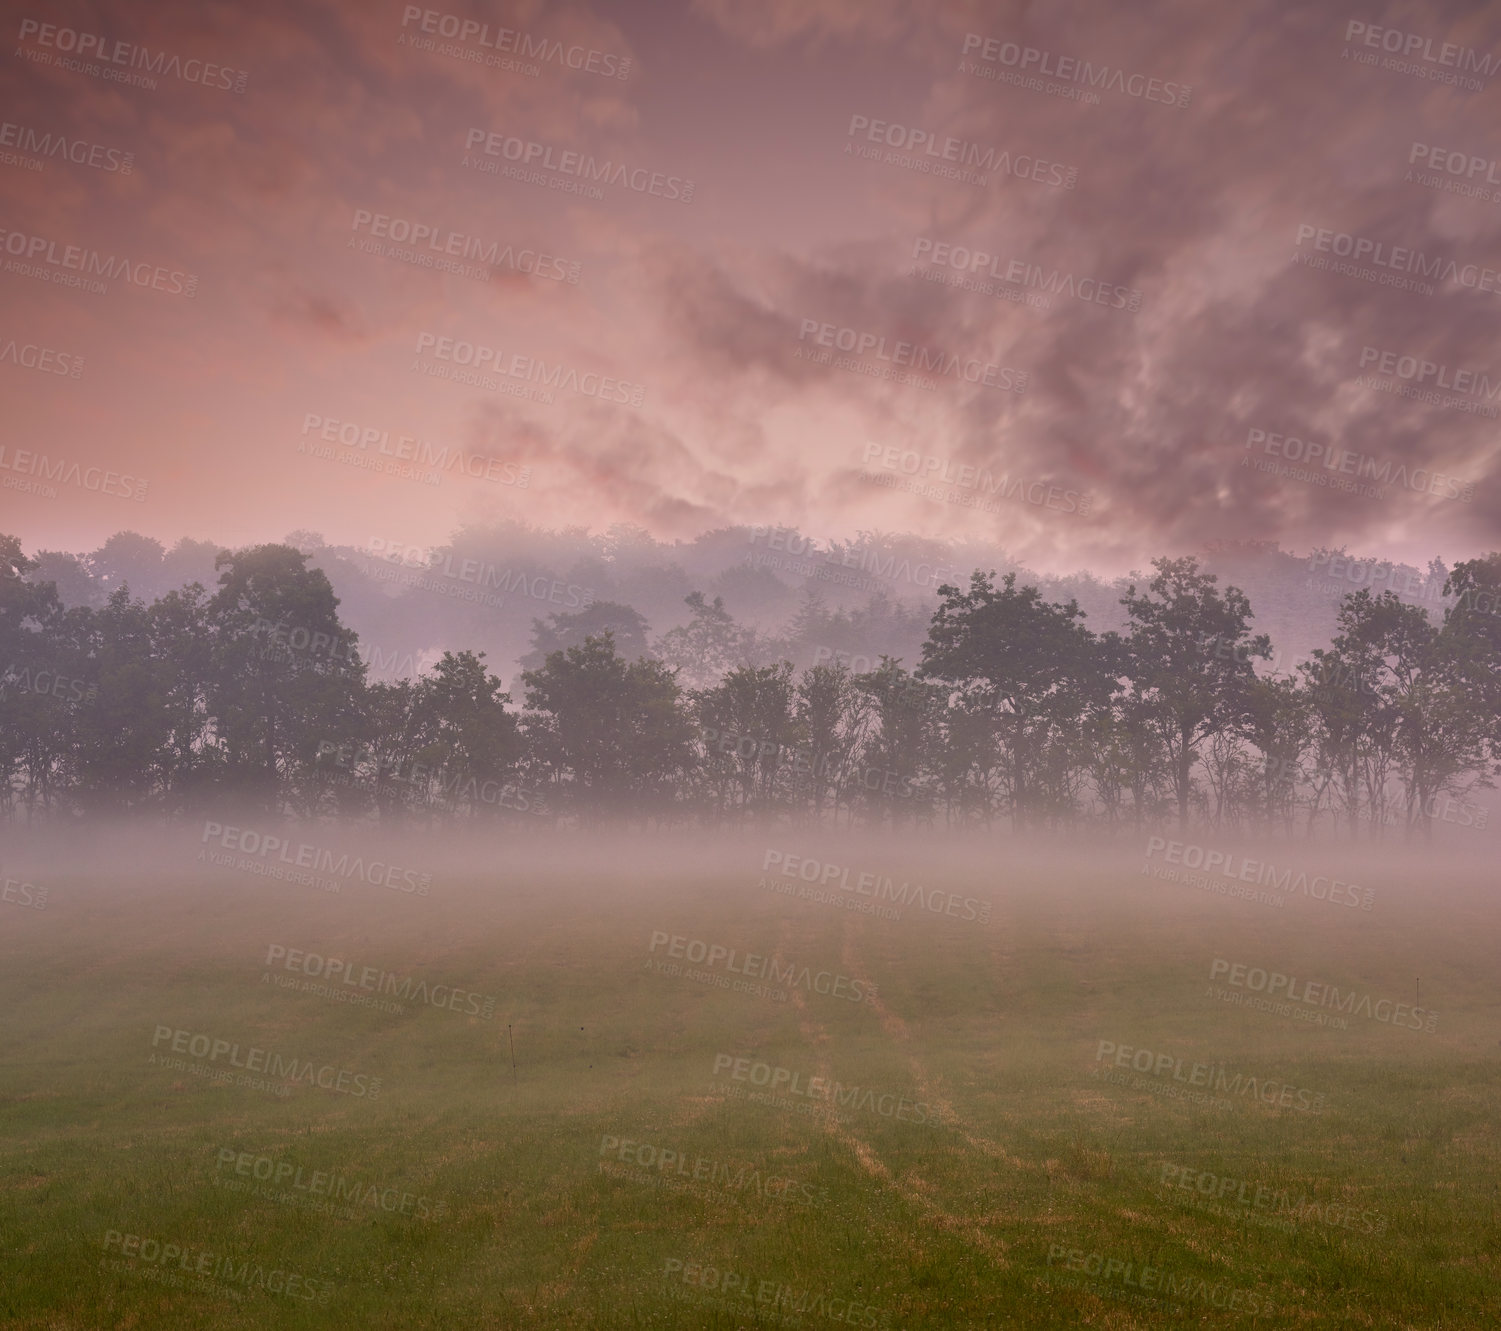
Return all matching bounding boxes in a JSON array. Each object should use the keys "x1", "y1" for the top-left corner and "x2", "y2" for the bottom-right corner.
[{"x1": 0, "y1": 0, "x2": 1501, "y2": 575}]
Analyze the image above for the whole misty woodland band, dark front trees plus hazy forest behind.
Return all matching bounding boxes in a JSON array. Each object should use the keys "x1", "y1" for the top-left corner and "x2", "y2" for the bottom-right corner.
[{"x1": 0, "y1": 525, "x2": 1501, "y2": 837}]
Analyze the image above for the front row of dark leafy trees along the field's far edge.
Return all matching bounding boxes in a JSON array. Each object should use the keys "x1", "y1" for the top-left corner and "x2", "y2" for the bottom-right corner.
[{"x1": 0, "y1": 537, "x2": 1501, "y2": 836}]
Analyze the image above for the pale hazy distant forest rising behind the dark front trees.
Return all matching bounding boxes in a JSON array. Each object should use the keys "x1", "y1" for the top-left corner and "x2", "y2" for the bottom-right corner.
[{"x1": 17, "y1": 521, "x2": 1447, "y2": 687}]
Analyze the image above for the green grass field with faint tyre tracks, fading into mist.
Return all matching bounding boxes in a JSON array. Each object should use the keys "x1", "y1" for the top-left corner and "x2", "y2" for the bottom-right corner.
[{"x1": 0, "y1": 836, "x2": 1501, "y2": 1331}]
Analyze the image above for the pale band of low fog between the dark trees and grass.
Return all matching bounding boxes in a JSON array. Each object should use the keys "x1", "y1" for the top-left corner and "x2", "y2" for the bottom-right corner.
[{"x1": 0, "y1": 812, "x2": 1495, "y2": 909}]
